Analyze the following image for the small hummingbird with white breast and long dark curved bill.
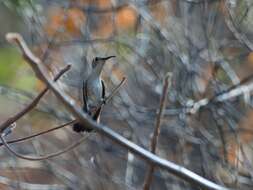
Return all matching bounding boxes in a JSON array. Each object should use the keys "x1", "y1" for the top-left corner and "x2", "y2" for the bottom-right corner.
[{"x1": 73, "y1": 56, "x2": 116, "y2": 133}]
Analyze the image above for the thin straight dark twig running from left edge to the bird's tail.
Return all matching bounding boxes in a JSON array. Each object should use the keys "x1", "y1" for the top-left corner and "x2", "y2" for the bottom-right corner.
[{"x1": 0, "y1": 120, "x2": 77, "y2": 147}]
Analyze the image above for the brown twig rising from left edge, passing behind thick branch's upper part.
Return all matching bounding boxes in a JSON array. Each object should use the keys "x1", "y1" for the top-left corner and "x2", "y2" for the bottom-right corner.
[{"x1": 0, "y1": 65, "x2": 71, "y2": 133}]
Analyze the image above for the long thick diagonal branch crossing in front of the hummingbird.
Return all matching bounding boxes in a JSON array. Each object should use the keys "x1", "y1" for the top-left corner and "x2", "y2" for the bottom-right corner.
[{"x1": 4, "y1": 34, "x2": 228, "y2": 190}]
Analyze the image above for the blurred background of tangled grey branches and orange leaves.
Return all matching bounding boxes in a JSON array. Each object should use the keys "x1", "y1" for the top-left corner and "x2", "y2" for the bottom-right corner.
[{"x1": 0, "y1": 0, "x2": 253, "y2": 190}]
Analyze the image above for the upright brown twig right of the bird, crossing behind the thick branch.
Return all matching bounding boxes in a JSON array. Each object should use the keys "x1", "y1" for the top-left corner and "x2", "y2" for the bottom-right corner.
[{"x1": 143, "y1": 74, "x2": 171, "y2": 190}]
